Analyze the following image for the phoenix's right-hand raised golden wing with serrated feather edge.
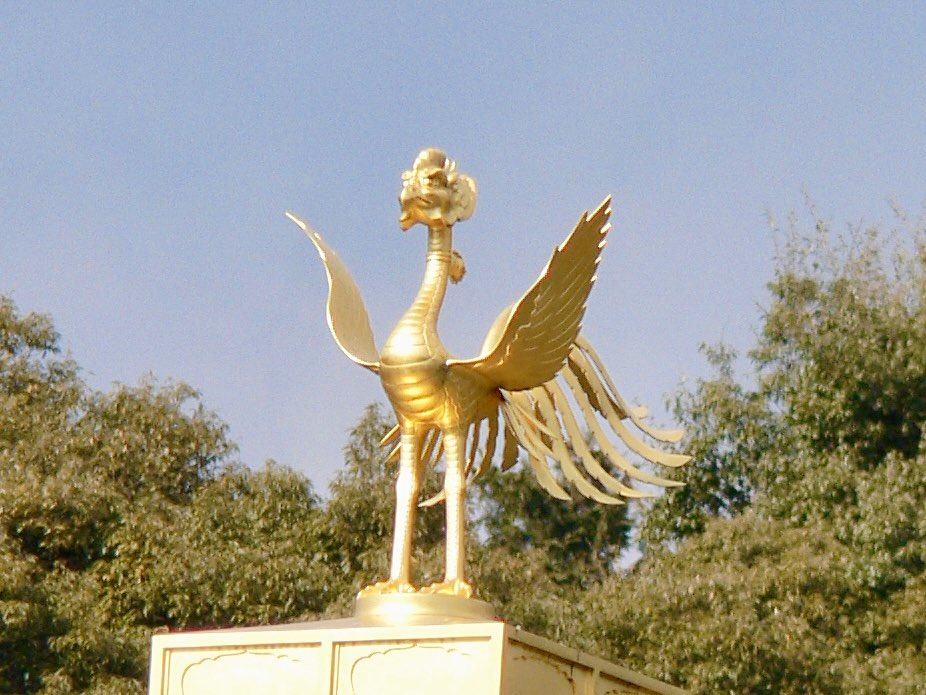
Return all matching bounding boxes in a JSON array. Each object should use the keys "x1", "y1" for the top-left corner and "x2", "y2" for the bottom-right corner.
[{"x1": 447, "y1": 196, "x2": 611, "y2": 391}]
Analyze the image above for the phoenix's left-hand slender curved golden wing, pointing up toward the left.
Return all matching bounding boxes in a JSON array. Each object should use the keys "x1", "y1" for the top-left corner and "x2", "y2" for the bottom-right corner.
[{"x1": 286, "y1": 212, "x2": 379, "y2": 372}]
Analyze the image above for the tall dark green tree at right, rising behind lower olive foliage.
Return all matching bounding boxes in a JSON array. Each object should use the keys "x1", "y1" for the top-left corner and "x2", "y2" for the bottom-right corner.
[{"x1": 644, "y1": 221, "x2": 926, "y2": 543}]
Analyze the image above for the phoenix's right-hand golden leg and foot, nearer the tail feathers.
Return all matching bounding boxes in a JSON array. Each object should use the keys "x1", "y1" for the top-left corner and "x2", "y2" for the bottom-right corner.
[{"x1": 426, "y1": 430, "x2": 473, "y2": 598}]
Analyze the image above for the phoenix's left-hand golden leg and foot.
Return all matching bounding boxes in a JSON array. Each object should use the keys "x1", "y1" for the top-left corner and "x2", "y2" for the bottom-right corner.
[{"x1": 360, "y1": 430, "x2": 422, "y2": 596}]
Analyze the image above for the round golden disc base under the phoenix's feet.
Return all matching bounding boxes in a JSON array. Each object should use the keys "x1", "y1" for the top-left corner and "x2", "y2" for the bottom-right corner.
[{"x1": 354, "y1": 593, "x2": 495, "y2": 625}]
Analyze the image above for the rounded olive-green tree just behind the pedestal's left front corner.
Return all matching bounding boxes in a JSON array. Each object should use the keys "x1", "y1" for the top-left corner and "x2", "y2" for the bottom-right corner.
[{"x1": 101, "y1": 462, "x2": 333, "y2": 628}]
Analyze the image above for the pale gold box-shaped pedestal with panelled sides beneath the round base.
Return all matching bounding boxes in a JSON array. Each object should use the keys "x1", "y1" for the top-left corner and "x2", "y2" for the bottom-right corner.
[{"x1": 149, "y1": 619, "x2": 684, "y2": 695}]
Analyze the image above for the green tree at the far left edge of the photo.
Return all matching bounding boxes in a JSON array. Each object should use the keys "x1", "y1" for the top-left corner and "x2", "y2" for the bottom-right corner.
[{"x1": 0, "y1": 298, "x2": 236, "y2": 692}]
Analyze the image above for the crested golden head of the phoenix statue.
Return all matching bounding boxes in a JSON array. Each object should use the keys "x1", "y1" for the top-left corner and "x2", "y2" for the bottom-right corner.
[{"x1": 399, "y1": 147, "x2": 476, "y2": 230}]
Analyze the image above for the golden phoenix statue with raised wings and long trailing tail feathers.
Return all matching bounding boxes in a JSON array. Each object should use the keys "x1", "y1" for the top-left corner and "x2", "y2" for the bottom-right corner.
[{"x1": 287, "y1": 149, "x2": 689, "y2": 598}]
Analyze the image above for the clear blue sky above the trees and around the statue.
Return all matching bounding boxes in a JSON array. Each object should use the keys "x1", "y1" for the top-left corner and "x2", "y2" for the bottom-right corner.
[{"x1": 0, "y1": 2, "x2": 926, "y2": 487}]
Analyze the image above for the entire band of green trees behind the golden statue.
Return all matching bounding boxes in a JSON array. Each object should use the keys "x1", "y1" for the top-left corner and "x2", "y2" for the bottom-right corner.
[{"x1": 0, "y1": 215, "x2": 926, "y2": 693}]
